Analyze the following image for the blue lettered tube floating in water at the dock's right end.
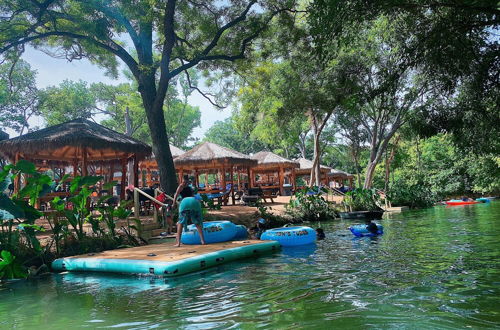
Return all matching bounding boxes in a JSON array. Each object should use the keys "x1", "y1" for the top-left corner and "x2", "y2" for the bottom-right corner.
[{"x1": 260, "y1": 226, "x2": 316, "y2": 246}]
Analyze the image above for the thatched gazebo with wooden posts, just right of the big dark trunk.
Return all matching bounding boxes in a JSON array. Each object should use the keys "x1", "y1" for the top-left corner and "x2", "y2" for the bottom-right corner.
[{"x1": 174, "y1": 142, "x2": 257, "y2": 205}]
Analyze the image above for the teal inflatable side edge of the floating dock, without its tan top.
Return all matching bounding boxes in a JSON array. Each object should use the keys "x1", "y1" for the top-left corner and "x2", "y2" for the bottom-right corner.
[{"x1": 52, "y1": 241, "x2": 280, "y2": 277}]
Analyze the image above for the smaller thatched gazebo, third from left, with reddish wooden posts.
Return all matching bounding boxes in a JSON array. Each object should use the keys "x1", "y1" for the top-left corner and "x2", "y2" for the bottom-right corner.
[{"x1": 250, "y1": 151, "x2": 300, "y2": 198}]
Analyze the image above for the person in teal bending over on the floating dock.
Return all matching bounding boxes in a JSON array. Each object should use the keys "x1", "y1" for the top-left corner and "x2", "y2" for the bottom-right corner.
[{"x1": 173, "y1": 175, "x2": 206, "y2": 247}]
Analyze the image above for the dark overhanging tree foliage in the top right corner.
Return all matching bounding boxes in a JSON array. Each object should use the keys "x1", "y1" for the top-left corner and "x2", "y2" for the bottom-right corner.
[{"x1": 308, "y1": 0, "x2": 500, "y2": 154}]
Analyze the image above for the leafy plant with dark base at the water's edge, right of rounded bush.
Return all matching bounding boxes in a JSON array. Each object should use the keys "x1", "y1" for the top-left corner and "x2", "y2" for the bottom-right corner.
[{"x1": 340, "y1": 188, "x2": 384, "y2": 219}]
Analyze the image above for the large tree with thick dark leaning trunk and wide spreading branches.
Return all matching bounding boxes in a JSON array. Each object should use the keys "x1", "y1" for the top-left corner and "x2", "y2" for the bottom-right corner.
[{"x1": 0, "y1": 0, "x2": 293, "y2": 193}]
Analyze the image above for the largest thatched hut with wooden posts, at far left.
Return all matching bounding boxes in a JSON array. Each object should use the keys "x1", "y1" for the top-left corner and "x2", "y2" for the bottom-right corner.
[{"x1": 0, "y1": 119, "x2": 151, "y2": 211}]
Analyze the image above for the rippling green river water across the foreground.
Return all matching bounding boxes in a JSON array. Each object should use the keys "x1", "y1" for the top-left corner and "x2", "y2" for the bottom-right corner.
[{"x1": 0, "y1": 202, "x2": 500, "y2": 329}]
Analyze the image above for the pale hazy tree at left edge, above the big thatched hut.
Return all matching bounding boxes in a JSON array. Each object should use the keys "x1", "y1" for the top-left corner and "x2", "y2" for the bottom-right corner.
[{"x1": 0, "y1": 59, "x2": 39, "y2": 134}]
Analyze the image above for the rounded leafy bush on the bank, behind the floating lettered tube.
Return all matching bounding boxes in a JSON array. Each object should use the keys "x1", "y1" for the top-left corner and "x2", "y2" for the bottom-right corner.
[{"x1": 286, "y1": 187, "x2": 336, "y2": 221}]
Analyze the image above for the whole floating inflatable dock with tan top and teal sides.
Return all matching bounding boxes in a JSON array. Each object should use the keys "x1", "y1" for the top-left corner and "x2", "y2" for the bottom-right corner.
[{"x1": 52, "y1": 240, "x2": 280, "y2": 277}]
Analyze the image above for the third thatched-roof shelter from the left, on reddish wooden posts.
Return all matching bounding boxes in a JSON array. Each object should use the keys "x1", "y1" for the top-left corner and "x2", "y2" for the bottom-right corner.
[{"x1": 251, "y1": 151, "x2": 300, "y2": 195}]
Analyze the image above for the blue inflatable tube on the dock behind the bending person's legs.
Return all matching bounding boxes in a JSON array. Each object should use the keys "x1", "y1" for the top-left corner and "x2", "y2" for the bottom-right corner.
[{"x1": 181, "y1": 221, "x2": 237, "y2": 245}]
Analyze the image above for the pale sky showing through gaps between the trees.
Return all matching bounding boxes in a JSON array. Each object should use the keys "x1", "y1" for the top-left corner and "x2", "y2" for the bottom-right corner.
[{"x1": 7, "y1": 47, "x2": 231, "y2": 139}]
